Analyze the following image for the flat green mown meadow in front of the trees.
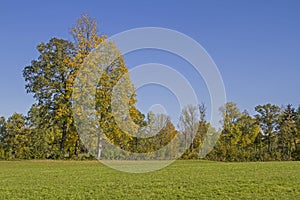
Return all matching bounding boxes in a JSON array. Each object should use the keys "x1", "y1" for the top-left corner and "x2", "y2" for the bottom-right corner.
[{"x1": 0, "y1": 161, "x2": 300, "y2": 199}]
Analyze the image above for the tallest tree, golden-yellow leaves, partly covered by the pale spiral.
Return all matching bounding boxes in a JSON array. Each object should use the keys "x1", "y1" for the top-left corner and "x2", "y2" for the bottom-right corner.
[{"x1": 70, "y1": 15, "x2": 145, "y2": 159}]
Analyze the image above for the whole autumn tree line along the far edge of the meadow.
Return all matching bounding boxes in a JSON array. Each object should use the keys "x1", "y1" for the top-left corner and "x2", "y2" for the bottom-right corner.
[{"x1": 0, "y1": 14, "x2": 300, "y2": 161}]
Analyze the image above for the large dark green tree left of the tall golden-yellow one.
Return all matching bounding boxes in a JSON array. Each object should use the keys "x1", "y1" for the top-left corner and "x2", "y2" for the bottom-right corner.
[{"x1": 23, "y1": 38, "x2": 75, "y2": 157}]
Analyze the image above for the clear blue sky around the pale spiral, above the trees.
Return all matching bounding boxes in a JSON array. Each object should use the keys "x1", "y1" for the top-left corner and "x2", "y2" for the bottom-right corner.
[{"x1": 0, "y1": 0, "x2": 300, "y2": 120}]
